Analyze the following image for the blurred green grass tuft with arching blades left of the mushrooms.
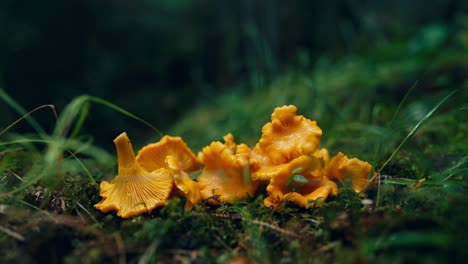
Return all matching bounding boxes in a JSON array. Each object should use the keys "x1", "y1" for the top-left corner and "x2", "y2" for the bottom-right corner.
[{"x1": 0, "y1": 93, "x2": 163, "y2": 200}]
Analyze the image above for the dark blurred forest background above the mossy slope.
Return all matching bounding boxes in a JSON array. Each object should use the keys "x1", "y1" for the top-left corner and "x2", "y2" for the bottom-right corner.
[{"x1": 0, "y1": 0, "x2": 468, "y2": 145}]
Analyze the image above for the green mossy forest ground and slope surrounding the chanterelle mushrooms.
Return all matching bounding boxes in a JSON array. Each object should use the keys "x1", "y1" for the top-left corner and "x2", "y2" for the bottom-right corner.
[{"x1": 0, "y1": 23, "x2": 468, "y2": 263}]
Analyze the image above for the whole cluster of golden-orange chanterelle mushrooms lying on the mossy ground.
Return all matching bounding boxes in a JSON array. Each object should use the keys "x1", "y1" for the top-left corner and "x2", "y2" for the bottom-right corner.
[{"x1": 95, "y1": 105, "x2": 375, "y2": 218}]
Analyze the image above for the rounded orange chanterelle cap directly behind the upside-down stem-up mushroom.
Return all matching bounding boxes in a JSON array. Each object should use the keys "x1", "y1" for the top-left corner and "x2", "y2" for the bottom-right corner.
[{"x1": 136, "y1": 136, "x2": 199, "y2": 172}]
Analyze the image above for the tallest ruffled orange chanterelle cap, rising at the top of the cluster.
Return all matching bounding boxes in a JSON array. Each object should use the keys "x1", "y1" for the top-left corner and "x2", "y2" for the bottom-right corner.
[{"x1": 251, "y1": 105, "x2": 322, "y2": 180}]
